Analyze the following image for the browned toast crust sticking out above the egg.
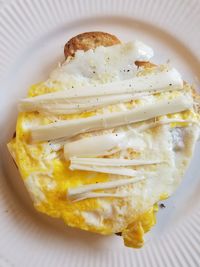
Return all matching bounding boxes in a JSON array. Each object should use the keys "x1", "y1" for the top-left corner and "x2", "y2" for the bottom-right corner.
[{"x1": 64, "y1": 32, "x2": 120, "y2": 58}]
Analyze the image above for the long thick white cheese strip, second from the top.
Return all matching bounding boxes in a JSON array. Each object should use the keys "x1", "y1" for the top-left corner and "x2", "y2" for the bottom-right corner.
[{"x1": 30, "y1": 95, "x2": 193, "y2": 141}]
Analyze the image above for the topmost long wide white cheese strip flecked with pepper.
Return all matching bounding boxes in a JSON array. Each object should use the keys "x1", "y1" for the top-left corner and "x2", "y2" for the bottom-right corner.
[{"x1": 18, "y1": 69, "x2": 183, "y2": 114}]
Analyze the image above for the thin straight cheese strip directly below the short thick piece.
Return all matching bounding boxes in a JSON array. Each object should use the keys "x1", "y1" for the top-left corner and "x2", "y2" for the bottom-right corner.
[{"x1": 70, "y1": 157, "x2": 163, "y2": 167}]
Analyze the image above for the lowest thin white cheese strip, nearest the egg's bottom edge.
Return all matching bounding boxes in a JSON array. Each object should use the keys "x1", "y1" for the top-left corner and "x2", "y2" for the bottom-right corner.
[{"x1": 72, "y1": 192, "x2": 131, "y2": 202}]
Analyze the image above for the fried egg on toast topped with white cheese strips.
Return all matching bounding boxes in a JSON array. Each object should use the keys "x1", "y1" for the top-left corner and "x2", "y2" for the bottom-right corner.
[{"x1": 8, "y1": 32, "x2": 200, "y2": 248}]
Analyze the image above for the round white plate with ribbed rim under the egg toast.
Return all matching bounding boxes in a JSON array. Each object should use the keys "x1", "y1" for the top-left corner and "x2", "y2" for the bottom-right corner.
[{"x1": 0, "y1": 0, "x2": 200, "y2": 267}]
